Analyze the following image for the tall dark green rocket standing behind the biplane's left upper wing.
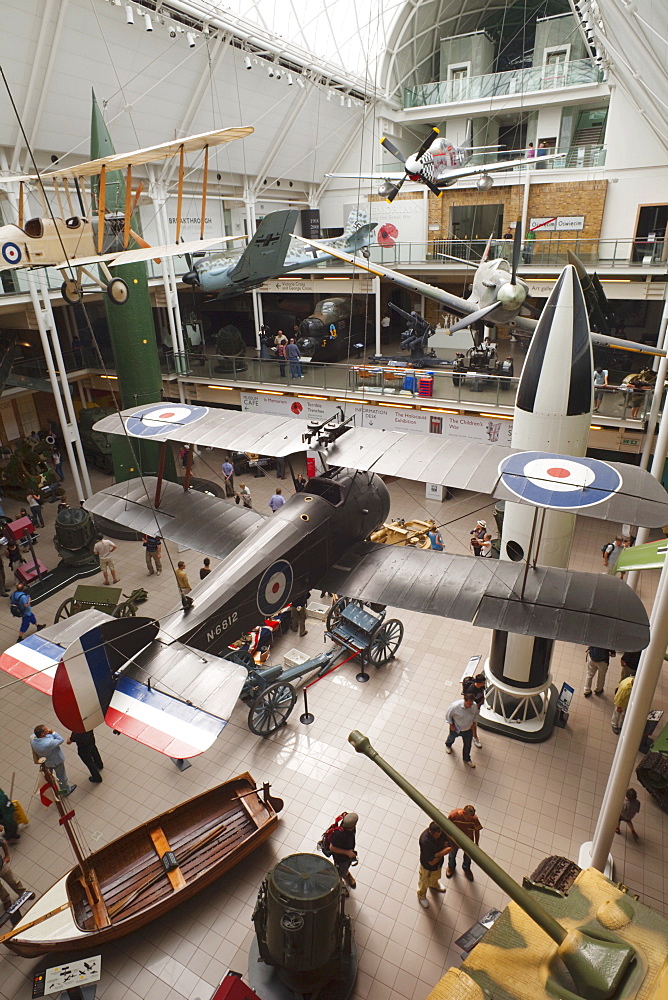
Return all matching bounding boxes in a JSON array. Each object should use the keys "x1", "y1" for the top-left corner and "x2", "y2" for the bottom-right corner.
[{"x1": 90, "y1": 94, "x2": 176, "y2": 482}]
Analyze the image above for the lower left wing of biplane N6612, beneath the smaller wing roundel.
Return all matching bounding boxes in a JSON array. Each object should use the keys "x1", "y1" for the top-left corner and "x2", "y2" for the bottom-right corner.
[{"x1": 86, "y1": 476, "x2": 266, "y2": 564}]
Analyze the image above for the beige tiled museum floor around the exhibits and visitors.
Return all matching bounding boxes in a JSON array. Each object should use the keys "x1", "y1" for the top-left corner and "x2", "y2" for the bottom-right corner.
[{"x1": 0, "y1": 452, "x2": 668, "y2": 1000}]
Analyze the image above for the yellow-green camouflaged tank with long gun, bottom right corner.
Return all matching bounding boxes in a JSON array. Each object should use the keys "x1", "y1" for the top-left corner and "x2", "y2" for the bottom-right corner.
[{"x1": 348, "y1": 731, "x2": 668, "y2": 1000}]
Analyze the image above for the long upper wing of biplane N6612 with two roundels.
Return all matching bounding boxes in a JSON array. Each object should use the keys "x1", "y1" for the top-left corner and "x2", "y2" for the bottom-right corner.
[{"x1": 90, "y1": 403, "x2": 668, "y2": 532}]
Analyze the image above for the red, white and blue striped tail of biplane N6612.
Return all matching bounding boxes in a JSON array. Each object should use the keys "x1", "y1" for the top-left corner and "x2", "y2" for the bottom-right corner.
[{"x1": 0, "y1": 609, "x2": 247, "y2": 758}]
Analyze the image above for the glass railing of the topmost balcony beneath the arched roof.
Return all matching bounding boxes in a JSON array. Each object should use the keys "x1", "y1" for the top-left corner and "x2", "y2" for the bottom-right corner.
[{"x1": 404, "y1": 59, "x2": 603, "y2": 108}]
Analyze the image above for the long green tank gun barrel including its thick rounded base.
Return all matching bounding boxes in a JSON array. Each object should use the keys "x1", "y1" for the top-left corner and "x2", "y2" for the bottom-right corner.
[{"x1": 348, "y1": 730, "x2": 636, "y2": 1000}]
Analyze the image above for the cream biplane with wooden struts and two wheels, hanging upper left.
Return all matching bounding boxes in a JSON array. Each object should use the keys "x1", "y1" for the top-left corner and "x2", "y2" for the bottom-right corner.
[{"x1": 0, "y1": 126, "x2": 253, "y2": 305}]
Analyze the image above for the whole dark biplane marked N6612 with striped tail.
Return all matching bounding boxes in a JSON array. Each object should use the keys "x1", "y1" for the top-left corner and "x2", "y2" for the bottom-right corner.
[{"x1": 0, "y1": 394, "x2": 668, "y2": 757}]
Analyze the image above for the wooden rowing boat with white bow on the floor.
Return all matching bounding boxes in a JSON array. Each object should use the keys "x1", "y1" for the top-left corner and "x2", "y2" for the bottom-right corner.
[{"x1": 0, "y1": 773, "x2": 282, "y2": 958}]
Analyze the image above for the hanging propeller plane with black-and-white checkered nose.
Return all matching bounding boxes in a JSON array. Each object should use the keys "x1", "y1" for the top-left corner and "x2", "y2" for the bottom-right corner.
[{"x1": 327, "y1": 123, "x2": 561, "y2": 203}]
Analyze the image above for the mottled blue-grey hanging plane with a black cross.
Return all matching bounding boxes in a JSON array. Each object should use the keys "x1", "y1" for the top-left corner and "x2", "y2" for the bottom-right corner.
[{"x1": 181, "y1": 209, "x2": 377, "y2": 299}]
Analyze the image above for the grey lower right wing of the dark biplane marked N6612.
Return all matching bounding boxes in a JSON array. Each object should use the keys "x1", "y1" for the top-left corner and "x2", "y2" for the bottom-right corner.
[{"x1": 318, "y1": 542, "x2": 649, "y2": 649}]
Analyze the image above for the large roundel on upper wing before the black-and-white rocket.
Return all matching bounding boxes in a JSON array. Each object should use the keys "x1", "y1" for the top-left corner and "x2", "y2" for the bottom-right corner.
[{"x1": 499, "y1": 451, "x2": 622, "y2": 510}]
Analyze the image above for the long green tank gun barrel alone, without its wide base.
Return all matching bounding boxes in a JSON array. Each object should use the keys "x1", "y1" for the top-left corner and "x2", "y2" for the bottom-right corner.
[{"x1": 348, "y1": 729, "x2": 566, "y2": 944}]
